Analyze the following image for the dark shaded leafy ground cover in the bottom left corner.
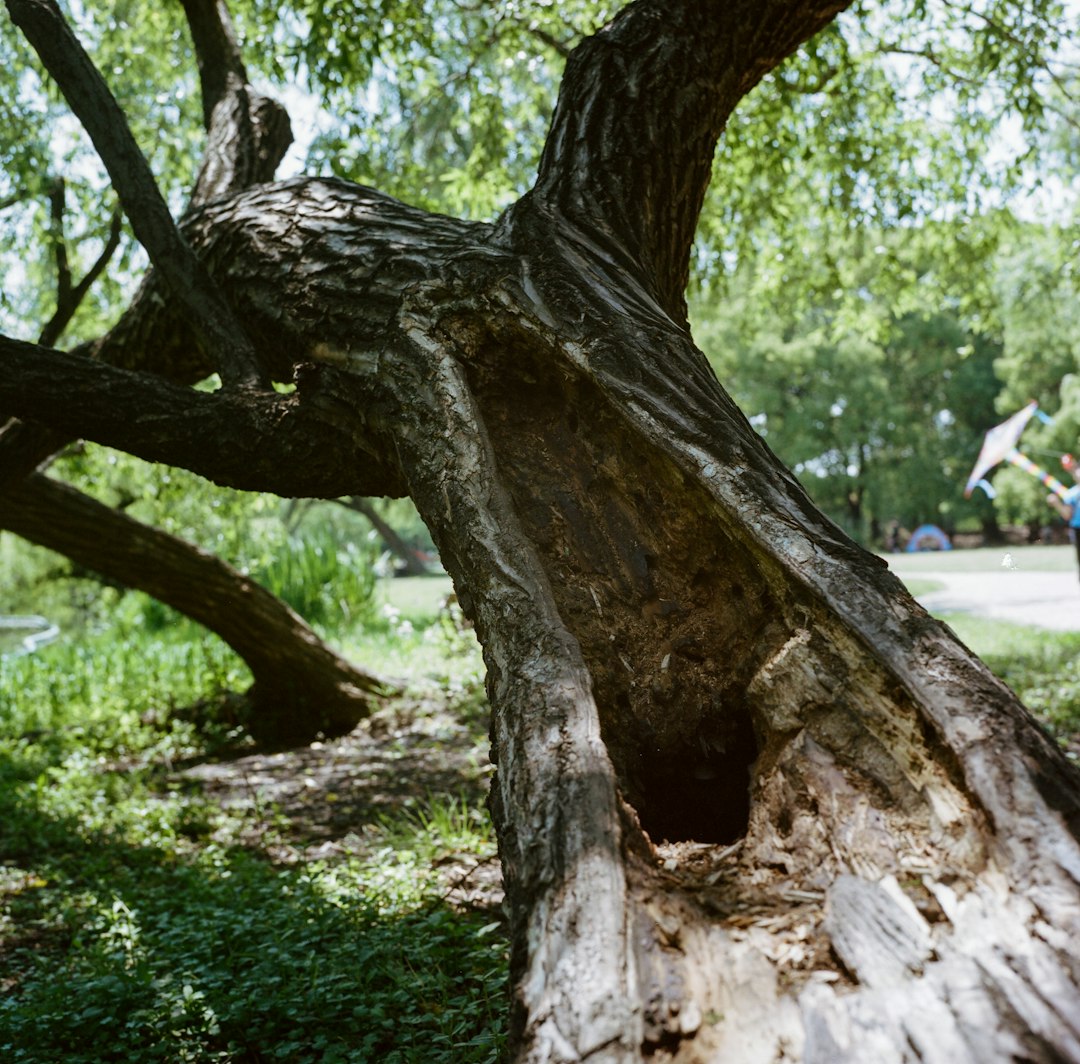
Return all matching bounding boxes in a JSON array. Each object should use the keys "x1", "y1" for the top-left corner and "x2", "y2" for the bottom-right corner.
[{"x1": 0, "y1": 753, "x2": 505, "y2": 1064}]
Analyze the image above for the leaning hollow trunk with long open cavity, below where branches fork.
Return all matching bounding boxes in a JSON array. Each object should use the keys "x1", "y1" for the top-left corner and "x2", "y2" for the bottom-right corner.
[{"x1": 382, "y1": 230, "x2": 1080, "y2": 1062}]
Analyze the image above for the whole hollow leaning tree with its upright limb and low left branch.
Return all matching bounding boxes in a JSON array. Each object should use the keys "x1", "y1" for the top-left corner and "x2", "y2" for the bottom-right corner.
[{"x1": 0, "y1": 0, "x2": 1080, "y2": 1064}]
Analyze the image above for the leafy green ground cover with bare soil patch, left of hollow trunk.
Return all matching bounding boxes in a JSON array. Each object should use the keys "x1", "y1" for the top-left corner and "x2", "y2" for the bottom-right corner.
[{"x1": 0, "y1": 604, "x2": 507, "y2": 1064}]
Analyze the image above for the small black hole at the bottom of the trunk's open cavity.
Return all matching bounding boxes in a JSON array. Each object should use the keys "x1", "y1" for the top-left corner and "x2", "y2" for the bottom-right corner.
[{"x1": 637, "y1": 713, "x2": 757, "y2": 845}]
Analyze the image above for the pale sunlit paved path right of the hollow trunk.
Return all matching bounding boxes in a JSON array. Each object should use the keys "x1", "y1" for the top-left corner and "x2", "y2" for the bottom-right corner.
[{"x1": 888, "y1": 548, "x2": 1080, "y2": 632}]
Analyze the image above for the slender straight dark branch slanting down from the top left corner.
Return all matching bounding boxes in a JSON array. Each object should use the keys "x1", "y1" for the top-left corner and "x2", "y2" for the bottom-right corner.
[{"x1": 5, "y1": 0, "x2": 266, "y2": 387}]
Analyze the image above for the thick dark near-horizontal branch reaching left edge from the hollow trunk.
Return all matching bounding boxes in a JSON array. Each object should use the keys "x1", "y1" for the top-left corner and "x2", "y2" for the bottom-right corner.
[{"x1": 0, "y1": 338, "x2": 402, "y2": 498}]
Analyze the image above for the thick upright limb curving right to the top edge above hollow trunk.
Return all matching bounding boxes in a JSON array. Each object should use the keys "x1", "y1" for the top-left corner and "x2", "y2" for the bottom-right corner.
[{"x1": 534, "y1": 0, "x2": 849, "y2": 322}]
